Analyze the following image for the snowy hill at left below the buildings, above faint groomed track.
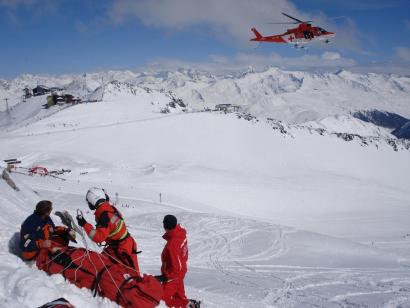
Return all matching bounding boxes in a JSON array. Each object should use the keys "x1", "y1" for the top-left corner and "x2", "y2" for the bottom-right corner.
[{"x1": 0, "y1": 81, "x2": 183, "y2": 131}]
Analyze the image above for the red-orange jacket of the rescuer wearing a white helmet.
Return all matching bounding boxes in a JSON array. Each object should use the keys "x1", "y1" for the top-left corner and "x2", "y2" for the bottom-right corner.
[{"x1": 84, "y1": 201, "x2": 128, "y2": 243}]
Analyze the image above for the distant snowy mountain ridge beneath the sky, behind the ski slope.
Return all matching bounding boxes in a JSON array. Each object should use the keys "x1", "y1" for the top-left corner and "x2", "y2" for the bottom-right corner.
[{"x1": 0, "y1": 67, "x2": 410, "y2": 140}]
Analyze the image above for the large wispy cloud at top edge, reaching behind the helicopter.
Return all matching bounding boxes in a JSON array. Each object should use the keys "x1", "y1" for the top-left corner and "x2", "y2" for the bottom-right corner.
[{"x1": 108, "y1": 0, "x2": 361, "y2": 50}]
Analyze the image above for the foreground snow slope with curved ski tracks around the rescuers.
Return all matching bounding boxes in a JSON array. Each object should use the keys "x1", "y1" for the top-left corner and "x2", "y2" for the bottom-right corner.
[{"x1": 0, "y1": 176, "x2": 409, "y2": 307}]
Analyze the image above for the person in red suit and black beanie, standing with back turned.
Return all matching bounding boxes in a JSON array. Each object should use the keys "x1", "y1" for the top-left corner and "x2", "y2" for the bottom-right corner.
[{"x1": 157, "y1": 215, "x2": 190, "y2": 308}]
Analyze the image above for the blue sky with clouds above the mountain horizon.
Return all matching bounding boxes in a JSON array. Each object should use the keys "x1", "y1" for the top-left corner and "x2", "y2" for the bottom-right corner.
[{"x1": 0, "y1": 0, "x2": 410, "y2": 79}]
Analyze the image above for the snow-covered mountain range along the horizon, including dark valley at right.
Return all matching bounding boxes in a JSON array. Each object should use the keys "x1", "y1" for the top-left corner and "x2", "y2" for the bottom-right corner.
[{"x1": 0, "y1": 68, "x2": 410, "y2": 146}]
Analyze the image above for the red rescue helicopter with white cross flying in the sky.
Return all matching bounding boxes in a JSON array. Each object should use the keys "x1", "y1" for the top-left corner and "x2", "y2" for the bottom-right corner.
[{"x1": 251, "y1": 13, "x2": 336, "y2": 48}]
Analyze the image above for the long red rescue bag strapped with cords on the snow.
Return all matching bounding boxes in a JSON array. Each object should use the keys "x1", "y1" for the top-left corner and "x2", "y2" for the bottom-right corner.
[{"x1": 36, "y1": 247, "x2": 163, "y2": 308}]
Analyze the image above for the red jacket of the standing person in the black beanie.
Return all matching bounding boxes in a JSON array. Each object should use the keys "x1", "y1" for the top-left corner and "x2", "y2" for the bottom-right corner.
[{"x1": 161, "y1": 225, "x2": 188, "y2": 280}]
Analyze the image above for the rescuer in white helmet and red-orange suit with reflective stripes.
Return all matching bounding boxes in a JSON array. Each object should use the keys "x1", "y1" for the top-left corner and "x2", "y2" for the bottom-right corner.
[{"x1": 77, "y1": 187, "x2": 140, "y2": 275}]
